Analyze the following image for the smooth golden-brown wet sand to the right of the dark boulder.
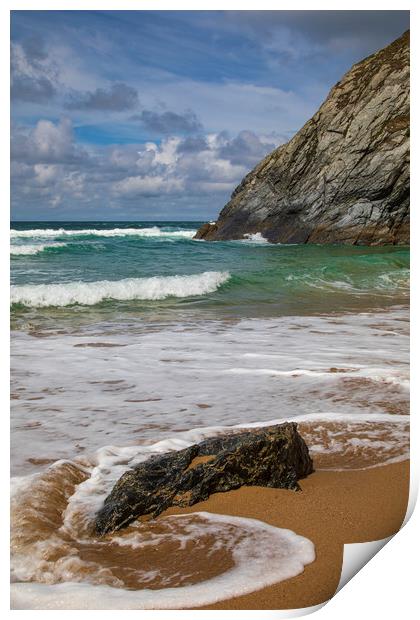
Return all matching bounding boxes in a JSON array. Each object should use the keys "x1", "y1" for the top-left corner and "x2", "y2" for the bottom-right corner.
[{"x1": 165, "y1": 461, "x2": 409, "y2": 609}]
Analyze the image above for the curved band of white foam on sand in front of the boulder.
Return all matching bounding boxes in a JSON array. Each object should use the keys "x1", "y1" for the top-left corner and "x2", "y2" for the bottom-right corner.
[{"x1": 11, "y1": 512, "x2": 315, "y2": 609}]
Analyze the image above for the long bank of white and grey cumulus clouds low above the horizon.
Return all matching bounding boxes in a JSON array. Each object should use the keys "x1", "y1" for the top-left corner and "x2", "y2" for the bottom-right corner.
[{"x1": 12, "y1": 118, "x2": 274, "y2": 213}]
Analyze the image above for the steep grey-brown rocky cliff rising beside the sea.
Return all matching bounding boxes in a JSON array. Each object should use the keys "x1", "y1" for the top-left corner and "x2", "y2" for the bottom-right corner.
[{"x1": 196, "y1": 32, "x2": 410, "y2": 245}]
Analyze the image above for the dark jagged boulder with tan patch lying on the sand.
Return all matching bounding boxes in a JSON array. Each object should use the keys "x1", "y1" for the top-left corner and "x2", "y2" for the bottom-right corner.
[{"x1": 95, "y1": 422, "x2": 313, "y2": 535}]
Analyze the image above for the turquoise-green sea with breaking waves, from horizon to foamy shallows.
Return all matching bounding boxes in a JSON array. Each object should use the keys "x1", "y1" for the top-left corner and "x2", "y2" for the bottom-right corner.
[{"x1": 11, "y1": 222, "x2": 409, "y2": 325}]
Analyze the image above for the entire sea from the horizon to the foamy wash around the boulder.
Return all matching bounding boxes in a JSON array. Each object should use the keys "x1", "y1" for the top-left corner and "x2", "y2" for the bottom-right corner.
[{"x1": 10, "y1": 221, "x2": 409, "y2": 609}]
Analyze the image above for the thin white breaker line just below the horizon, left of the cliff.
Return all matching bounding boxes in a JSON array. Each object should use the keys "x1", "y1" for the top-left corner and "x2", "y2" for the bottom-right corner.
[{"x1": 10, "y1": 226, "x2": 196, "y2": 239}]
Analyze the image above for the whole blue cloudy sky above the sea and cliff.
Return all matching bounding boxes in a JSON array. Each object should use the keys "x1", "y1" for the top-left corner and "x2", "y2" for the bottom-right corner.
[{"x1": 11, "y1": 11, "x2": 409, "y2": 221}]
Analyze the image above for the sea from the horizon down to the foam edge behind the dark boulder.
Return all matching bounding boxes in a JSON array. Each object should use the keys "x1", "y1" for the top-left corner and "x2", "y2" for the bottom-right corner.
[{"x1": 11, "y1": 222, "x2": 409, "y2": 473}]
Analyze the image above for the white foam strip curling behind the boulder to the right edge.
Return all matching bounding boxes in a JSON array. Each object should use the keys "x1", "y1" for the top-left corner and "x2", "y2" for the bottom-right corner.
[{"x1": 54, "y1": 413, "x2": 409, "y2": 532}]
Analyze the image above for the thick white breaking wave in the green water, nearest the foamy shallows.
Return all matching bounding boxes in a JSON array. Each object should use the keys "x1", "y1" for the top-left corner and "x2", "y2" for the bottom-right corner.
[{"x1": 10, "y1": 271, "x2": 230, "y2": 308}]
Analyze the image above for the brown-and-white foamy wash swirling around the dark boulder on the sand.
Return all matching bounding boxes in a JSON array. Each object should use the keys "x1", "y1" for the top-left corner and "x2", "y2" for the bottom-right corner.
[{"x1": 11, "y1": 406, "x2": 408, "y2": 609}]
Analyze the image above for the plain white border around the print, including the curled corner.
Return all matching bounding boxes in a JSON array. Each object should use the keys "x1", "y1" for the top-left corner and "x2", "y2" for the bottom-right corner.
[{"x1": 0, "y1": 0, "x2": 420, "y2": 620}]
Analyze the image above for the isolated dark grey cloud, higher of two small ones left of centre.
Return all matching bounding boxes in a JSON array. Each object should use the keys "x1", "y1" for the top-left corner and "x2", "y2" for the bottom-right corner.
[{"x1": 65, "y1": 82, "x2": 139, "y2": 112}]
